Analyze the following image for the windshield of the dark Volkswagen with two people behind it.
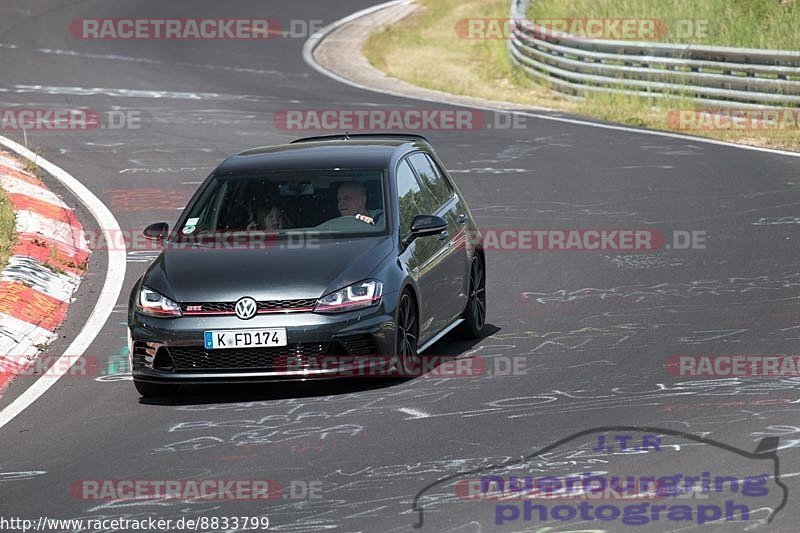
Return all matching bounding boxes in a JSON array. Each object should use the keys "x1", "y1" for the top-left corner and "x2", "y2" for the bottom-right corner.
[{"x1": 175, "y1": 168, "x2": 387, "y2": 241}]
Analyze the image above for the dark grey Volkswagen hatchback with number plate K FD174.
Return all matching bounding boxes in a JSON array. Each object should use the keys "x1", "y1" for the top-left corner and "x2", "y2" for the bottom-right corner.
[{"x1": 128, "y1": 134, "x2": 486, "y2": 396}]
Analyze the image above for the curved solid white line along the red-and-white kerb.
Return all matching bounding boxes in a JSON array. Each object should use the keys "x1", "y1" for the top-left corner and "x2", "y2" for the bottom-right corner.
[{"x1": 0, "y1": 136, "x2": 126, "y2": 428}]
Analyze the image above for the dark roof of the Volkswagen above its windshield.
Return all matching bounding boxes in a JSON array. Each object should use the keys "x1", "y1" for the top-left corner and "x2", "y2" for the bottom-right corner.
[{"x1": 215, "y1": 137, "x2": 431, "y2": 175}]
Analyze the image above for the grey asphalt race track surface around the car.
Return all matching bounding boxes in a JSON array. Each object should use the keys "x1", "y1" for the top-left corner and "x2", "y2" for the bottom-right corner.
[{"x1": 0, "y1": 0, "x2": 800, "y2": 532}]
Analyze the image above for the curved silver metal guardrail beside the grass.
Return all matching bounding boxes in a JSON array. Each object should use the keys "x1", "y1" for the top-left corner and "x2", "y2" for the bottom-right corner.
[{"x1": 508, "y1": 0, "x2": 800, "y2": 107}]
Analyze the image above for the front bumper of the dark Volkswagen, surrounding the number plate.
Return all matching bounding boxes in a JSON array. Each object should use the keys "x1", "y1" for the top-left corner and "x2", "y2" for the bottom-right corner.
[{"x1": 129, "y1": 293, "x2": 397, "y2": 384}]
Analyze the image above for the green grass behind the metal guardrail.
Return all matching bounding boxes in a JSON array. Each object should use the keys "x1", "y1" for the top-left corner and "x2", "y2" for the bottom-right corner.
[{"x1": 528, "y1": 0, "x2": 800, "y2": 50}]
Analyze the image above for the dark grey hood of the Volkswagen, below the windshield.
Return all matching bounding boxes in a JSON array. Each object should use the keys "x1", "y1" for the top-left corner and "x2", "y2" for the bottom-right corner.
[{"x1": 143, "y1": 236, "x2": 394, "y2": 302}]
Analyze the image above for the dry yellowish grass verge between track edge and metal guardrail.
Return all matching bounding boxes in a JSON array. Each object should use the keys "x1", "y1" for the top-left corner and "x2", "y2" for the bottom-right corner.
[{"x1": 364, "y1": 0, "x2": 800, "y2": 151}]
